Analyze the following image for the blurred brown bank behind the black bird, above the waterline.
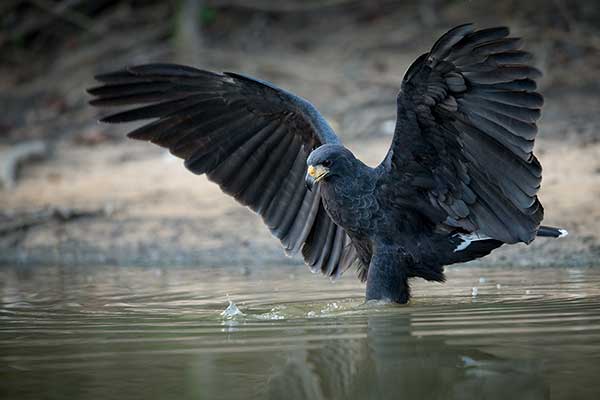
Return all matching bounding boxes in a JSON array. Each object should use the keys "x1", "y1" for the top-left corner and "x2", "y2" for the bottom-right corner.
[{"x1": 0, "y1": 0, "x2": 600, "y2": 268}]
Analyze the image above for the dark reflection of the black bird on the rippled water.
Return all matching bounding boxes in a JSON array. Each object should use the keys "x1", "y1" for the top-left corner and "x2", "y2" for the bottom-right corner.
[{"x1": 250, "y1": 314, "x2": 550, "y2": 400}]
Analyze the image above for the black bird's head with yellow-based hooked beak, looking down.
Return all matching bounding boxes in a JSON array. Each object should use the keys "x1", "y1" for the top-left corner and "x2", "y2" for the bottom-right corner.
[{"x1": 305, "y1": 144, "x2": 356, "y2": 190}]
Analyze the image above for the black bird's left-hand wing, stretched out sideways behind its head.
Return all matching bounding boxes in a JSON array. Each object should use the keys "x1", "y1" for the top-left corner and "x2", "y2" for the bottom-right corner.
[{"x1": 88, "y1": 64, "x2": 356, "y2": 276}]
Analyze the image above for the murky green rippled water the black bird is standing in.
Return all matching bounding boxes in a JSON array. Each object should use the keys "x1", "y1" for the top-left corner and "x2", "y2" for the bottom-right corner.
[{"x1": 0, "y1": 267, "x2": 600, "y2": 400}]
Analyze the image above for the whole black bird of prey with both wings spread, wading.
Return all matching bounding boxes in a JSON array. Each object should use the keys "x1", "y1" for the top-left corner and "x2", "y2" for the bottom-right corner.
[{"x1": 89, "y1": 24, "x2": 566, "y2": 303}]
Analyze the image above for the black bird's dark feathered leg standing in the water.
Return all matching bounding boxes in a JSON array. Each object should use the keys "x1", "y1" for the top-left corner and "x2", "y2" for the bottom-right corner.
[{"x1": 366, "y1": 251, "x2": 410, "y2": 304}]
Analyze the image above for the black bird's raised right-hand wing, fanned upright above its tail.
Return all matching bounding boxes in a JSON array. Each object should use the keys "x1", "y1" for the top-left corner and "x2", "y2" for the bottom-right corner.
[{"x1": 381, "y1": 24, "x2": 543, "y2": 243}]
